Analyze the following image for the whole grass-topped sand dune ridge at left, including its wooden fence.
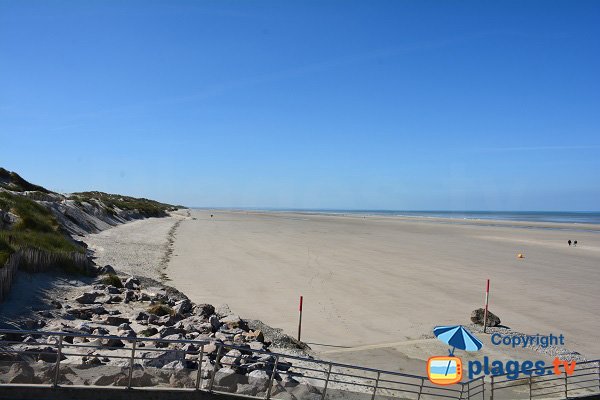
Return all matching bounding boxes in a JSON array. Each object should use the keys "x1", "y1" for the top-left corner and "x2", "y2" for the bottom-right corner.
[{"x1": 0, "y1": 168, "x2": 177, "y2": 300}]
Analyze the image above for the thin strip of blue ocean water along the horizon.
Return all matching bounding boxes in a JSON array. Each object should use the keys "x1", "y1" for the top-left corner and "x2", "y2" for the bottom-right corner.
[{"x1": 284, "y1": 209, "x2": 600, "y2": 224}]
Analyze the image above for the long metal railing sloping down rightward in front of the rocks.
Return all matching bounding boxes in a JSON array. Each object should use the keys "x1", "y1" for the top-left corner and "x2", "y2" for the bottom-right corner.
[{"x1": 0, "y1": 330, "x2": 478, "y2": 400}]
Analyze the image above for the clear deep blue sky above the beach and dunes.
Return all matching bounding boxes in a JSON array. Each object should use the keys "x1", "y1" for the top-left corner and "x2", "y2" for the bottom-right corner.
[{"x1": 0, "y1": 0, "x2": 600, "y2": 210}]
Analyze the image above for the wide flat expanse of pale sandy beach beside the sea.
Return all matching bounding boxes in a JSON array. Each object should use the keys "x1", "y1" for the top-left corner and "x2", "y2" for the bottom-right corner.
[{"x1": 81, "y1": 210, "x2": 600, "y2": 372}]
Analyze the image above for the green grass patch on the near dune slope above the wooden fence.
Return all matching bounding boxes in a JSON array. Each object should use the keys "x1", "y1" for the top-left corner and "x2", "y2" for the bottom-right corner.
[{"x1": 0, "y1": 192, "x2": 85, "y2": 269}]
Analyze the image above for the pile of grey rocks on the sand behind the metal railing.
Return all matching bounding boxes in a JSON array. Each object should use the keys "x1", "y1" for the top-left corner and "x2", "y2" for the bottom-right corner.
[{"x1": 0, "y1": 271, "x2": 319, "y2": 399}]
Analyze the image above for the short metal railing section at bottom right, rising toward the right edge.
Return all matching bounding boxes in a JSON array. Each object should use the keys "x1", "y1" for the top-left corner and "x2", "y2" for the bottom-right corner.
[{"x1": 490, "y1": 360, "x2": 600, "y2": 400}]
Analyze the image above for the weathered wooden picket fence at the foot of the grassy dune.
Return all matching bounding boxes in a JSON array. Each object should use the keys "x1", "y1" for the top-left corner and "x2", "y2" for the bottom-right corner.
[{"x1": 0, "y1": 248, "x2": 93, "y2": 301}]
